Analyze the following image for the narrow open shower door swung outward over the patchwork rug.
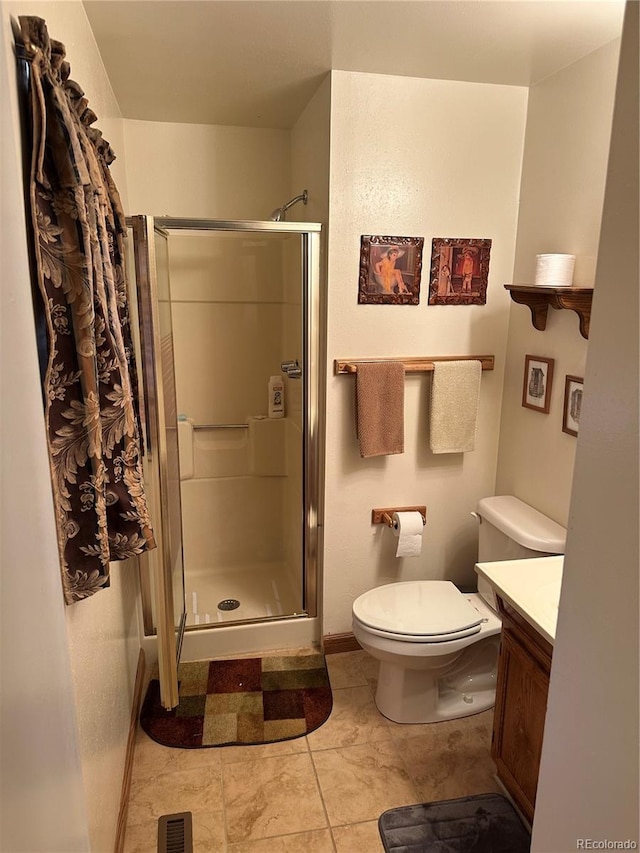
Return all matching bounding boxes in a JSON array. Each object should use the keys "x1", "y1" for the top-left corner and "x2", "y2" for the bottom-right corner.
[{"x1": 128, "y1": 216, "x2": 186, "y2": 709}]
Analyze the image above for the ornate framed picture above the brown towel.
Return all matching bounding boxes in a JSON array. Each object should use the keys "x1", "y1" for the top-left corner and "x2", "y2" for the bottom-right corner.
[{"x1": 358, "y1": 236, "x2": 424, "y2": 305}]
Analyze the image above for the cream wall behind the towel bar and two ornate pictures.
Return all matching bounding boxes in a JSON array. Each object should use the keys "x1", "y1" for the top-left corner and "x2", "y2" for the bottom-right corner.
[{"x1": 323, "y1": 72, "x2": 527, "y2": 634}]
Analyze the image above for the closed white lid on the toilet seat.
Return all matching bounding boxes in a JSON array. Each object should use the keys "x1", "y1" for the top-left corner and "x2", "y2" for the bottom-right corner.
[{"x1": 353, "y1": 581, "x2": 482, "y2": 638}]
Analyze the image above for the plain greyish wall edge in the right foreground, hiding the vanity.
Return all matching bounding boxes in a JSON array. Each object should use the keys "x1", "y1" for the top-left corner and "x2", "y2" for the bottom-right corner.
[{"x1": 531, "y1": 3, "x2": 640, "y2": 853}]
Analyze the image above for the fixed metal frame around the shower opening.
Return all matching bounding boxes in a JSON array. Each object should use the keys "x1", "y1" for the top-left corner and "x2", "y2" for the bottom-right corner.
[{"x1": 143, "y1": 216, "x2": 322, "y2": 632}]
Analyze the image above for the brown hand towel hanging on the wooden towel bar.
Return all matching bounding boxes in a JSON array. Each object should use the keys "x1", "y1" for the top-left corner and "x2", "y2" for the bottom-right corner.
[{"x1": 356, "y1": 361, "x2": 404, "y2": 457}]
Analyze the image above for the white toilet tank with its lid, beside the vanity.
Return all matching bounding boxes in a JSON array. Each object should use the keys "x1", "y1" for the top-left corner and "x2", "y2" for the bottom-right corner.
[{"x1": 477, "y1": 495, "x2": 567, "y2": 610}]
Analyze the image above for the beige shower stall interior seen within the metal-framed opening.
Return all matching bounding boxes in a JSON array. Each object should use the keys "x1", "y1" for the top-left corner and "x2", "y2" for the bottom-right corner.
[{"x1": 168, "y1": 225, "x2": 308, "y2": 629}]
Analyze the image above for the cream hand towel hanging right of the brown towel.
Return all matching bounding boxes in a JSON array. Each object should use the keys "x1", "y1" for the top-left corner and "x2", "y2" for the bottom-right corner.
[{"x1": 430, "y1": 361, "x2": 482, "y2": 453}]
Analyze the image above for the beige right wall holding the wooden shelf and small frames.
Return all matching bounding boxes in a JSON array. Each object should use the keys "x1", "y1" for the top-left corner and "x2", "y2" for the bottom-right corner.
[{"x1": 496, "y1": 42, "x2": 619, "y2": 527}]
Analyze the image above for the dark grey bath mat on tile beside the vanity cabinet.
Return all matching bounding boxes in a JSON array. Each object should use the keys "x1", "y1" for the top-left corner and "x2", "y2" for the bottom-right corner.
[{"x1": 378, "y1": 794, "x2": 531, "y2": 853}]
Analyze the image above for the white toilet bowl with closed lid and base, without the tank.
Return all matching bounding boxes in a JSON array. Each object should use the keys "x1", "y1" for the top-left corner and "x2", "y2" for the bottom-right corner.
[{"x1": 353, "y1": 581, "x2": 501, "y2": 723}]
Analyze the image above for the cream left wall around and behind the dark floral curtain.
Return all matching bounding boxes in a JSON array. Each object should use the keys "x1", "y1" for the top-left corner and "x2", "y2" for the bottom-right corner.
[{"x1": 0, "y1": 2, "x2": 139, "y2": 853}]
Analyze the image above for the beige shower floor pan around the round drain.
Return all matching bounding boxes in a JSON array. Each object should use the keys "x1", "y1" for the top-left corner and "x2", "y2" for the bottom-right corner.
[{"x1": 185, "y1": 563, "x2": 302, "y2": 628}]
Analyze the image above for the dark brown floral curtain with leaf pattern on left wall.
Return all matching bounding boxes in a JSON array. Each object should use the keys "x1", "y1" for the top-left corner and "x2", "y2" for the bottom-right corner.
[{"x1": 20, "y1": 17, "x2": 155, "y2": 604}]
